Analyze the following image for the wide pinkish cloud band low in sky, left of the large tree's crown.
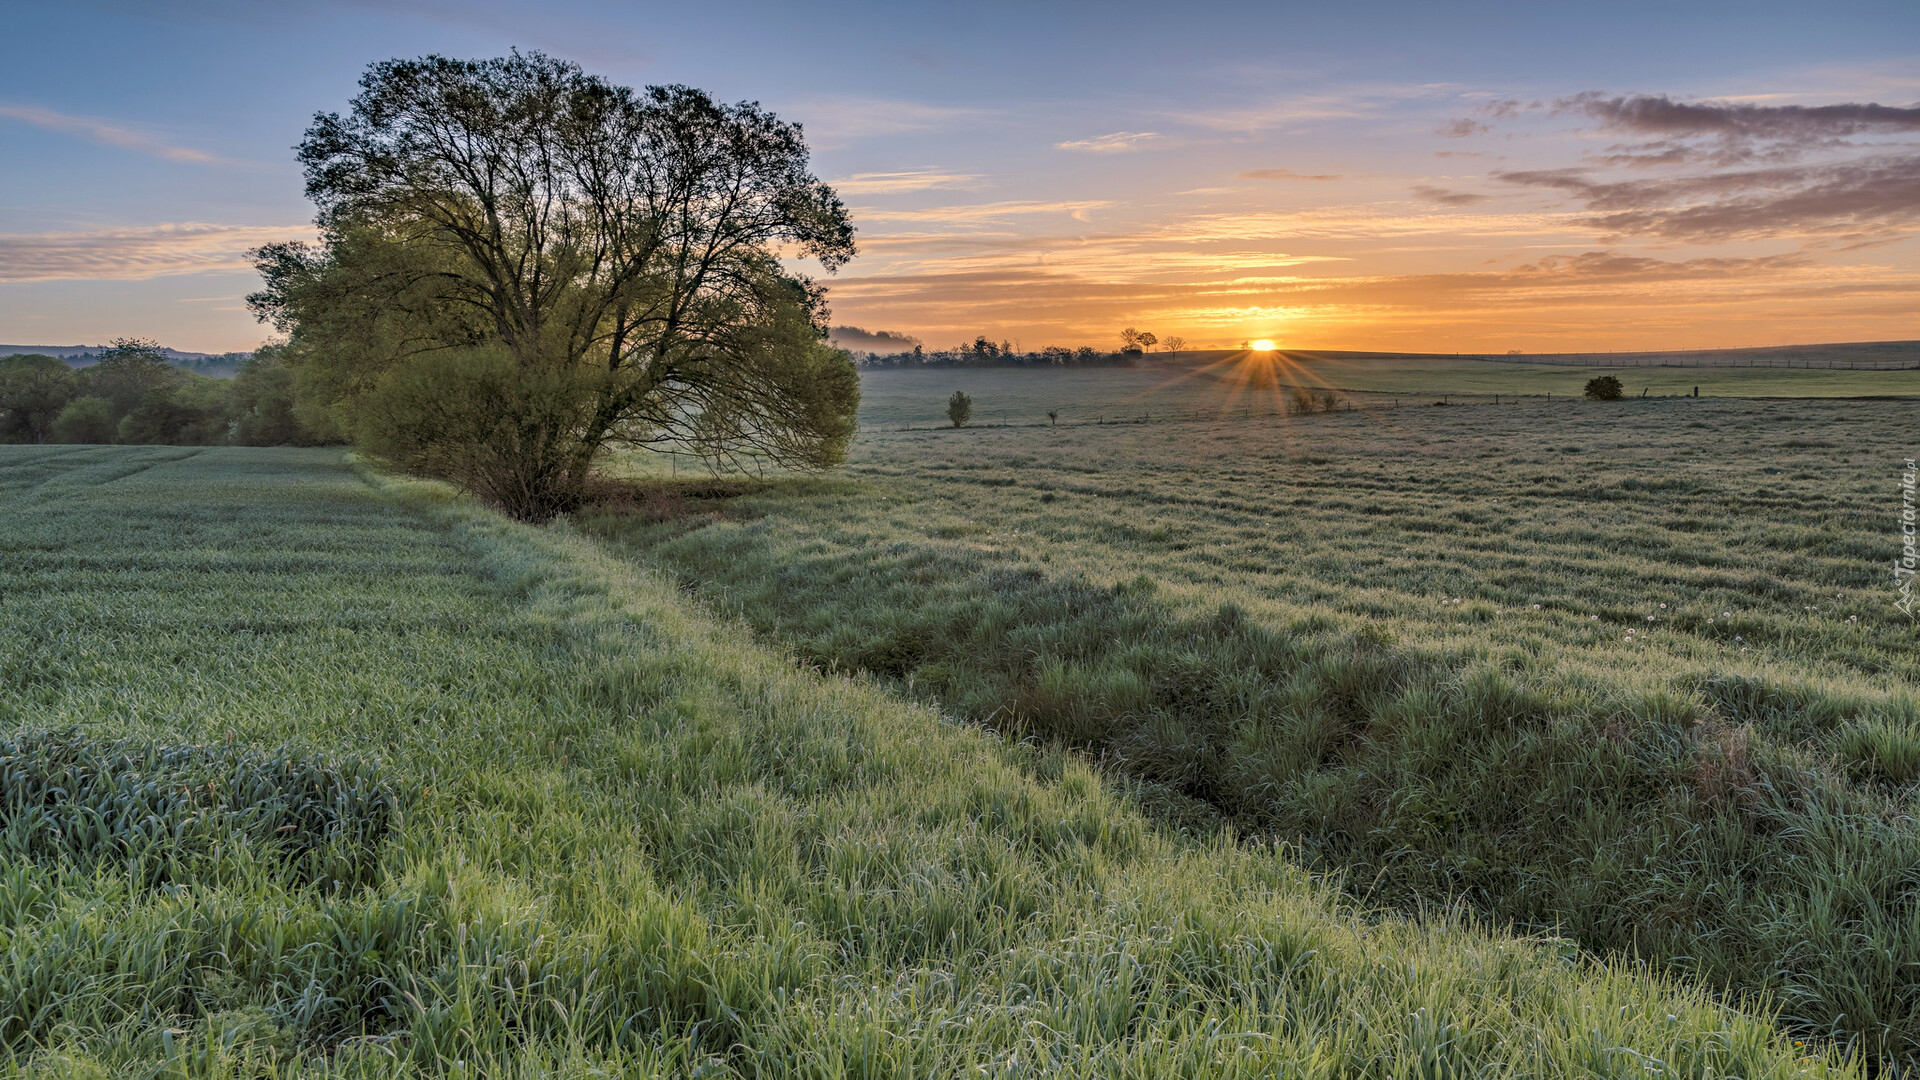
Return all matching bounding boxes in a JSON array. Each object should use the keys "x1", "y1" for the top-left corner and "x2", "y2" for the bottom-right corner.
[{"x1": 0, "y1": 221, "x2": 315, "y2": 281}]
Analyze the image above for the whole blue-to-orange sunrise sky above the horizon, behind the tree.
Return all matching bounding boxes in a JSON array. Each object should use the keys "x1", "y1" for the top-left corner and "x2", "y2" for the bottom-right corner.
[{"x1": 0, "y1": 0, "x2": 1920, "y2": 352}]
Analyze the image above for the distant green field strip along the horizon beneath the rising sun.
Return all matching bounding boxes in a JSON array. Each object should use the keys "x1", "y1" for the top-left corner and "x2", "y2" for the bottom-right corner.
[{"x1": 860, "y1": 354, "x2": 1920, "y2": 429}]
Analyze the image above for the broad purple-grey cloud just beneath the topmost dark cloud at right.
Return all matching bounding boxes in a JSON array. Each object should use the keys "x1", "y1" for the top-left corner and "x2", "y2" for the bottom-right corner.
[{"x1": 1494, "y1": 156, "x2": 1920, "y2": 244}]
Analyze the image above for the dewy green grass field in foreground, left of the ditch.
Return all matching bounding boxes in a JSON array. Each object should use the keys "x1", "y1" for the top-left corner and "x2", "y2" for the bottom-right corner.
[{"x1": 0, "y1": 448, "x2": 1855, "y2": 1078}]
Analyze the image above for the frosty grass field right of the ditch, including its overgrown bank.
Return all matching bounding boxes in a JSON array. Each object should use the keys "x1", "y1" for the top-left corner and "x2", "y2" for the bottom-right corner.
[{"x1": 582, "y1": 382, "x2": 1920, "y2": 1061}]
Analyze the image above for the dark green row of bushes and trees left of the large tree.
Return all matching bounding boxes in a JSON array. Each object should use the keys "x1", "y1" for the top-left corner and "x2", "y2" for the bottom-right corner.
[{"x1": 0, "y1": 338, "x2": 319, "y2": 446}]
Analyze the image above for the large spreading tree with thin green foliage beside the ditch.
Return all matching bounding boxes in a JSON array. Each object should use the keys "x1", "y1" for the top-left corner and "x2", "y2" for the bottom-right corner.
[{"x1": 252, "y1": 52, "x2": 858, "y2": 519}]
